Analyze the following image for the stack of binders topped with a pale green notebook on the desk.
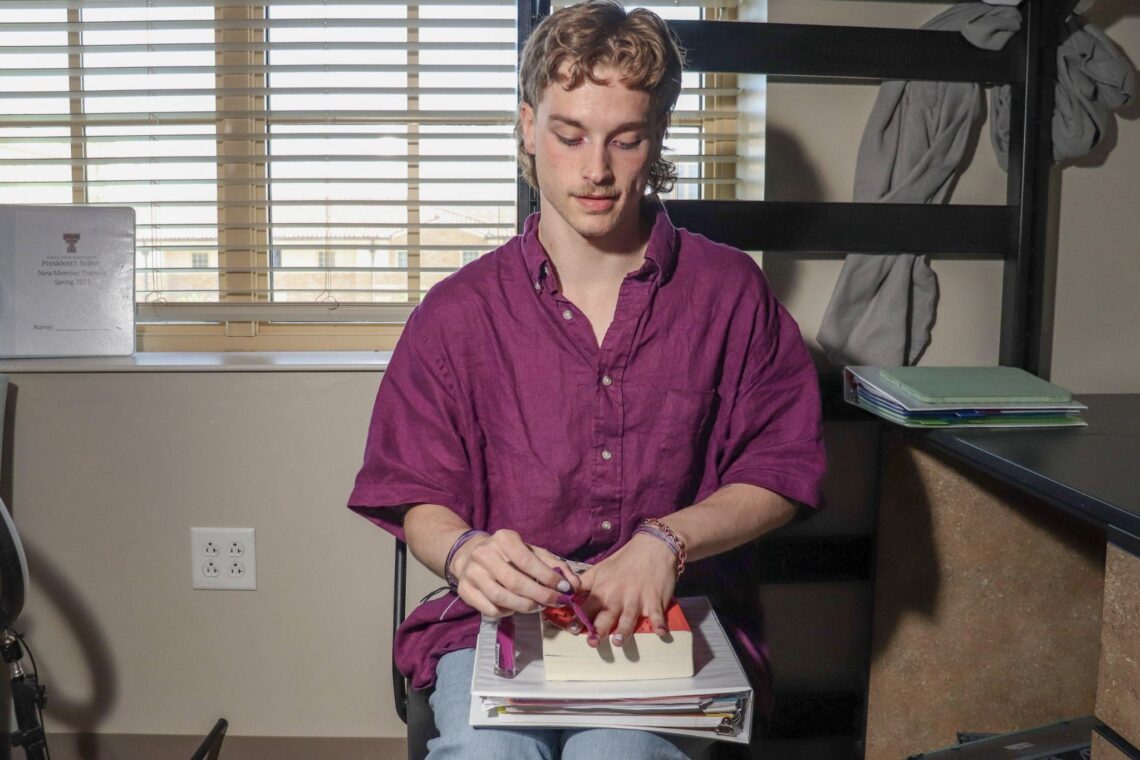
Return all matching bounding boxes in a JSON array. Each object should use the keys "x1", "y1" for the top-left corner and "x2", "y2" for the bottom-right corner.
[{"x1": 844, "y1": 367, "x2": 1088, "y2": 427}]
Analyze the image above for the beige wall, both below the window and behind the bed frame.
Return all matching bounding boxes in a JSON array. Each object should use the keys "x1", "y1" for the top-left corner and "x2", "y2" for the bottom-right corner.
[{"x1": 2, "y1": 0, "x2": 1140, "y2": 736}]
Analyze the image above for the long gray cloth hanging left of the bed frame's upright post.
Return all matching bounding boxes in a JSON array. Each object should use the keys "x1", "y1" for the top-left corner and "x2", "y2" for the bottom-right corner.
[{"x1": 816, "y1": 2, "x2": 1021, "y2": 366}]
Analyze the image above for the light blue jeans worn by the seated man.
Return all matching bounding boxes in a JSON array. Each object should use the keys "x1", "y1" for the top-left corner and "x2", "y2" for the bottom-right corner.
[{"x1": 428, "y1": 649, "x2": 713, "y2": 760}]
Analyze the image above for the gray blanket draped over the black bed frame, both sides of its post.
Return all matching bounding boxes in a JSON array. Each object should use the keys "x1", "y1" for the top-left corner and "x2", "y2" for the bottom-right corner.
[{"x1": 816, "y1": 2, "x2": 1133, "y2": 366}]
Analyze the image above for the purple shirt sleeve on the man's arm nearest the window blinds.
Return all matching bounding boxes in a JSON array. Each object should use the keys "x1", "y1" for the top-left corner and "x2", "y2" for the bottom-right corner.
[{"x1": 349, "y1": 311, "x2": 472, "y2": 540}]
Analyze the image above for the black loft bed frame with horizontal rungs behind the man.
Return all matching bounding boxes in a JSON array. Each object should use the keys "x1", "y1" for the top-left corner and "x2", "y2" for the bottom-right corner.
[{"x1": 392, "y1": 0, "x2": 1075, "y2": 757}]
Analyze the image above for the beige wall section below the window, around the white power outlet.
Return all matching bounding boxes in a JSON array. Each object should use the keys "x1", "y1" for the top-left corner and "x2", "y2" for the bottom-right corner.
[{"x1": 3, "y1": 371, "x2": 440, "y2": 736}]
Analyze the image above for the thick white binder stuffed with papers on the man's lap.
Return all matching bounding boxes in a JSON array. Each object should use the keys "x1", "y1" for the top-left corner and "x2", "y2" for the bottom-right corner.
[{"x1": 471, "y1": 597, "x2": 752, "y2": 743}]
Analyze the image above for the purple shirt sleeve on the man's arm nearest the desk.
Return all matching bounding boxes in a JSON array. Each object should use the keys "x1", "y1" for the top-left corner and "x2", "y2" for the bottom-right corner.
[{"x1": 718, "y1": 295, "x2": 825, "y2": 507}]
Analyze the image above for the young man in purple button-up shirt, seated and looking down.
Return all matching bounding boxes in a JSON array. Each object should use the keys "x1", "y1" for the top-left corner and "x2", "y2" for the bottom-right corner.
[{"x1": 350, "y1": 0, "x2": 823, "y2": 758}]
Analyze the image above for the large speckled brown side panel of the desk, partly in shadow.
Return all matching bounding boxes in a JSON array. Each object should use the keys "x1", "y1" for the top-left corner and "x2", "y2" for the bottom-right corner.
[{"x1": 866, "y1": 435, "x2": 1104, "y2": 760}]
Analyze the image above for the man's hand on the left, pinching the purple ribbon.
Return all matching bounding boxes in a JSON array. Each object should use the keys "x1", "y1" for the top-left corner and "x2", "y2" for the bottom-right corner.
[{"x1": 450, "y1": 530, "x2": 581, "y2": 618}]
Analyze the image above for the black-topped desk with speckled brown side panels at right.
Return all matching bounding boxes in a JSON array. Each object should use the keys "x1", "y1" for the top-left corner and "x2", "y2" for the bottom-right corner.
[{"x1": 866, "y1": 395, "x2": 1140, "y2": 760}]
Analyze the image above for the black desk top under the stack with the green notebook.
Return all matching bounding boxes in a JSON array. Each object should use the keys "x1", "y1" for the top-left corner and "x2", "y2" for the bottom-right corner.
[{"x1": 926, "y1": 393, "x2": 1140, "y2": 554}]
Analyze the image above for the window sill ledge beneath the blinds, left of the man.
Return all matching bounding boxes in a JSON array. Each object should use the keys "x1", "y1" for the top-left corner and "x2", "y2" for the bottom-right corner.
[{"x1": 0, "y1": 351, "x2": 392, "y2": 375}]
